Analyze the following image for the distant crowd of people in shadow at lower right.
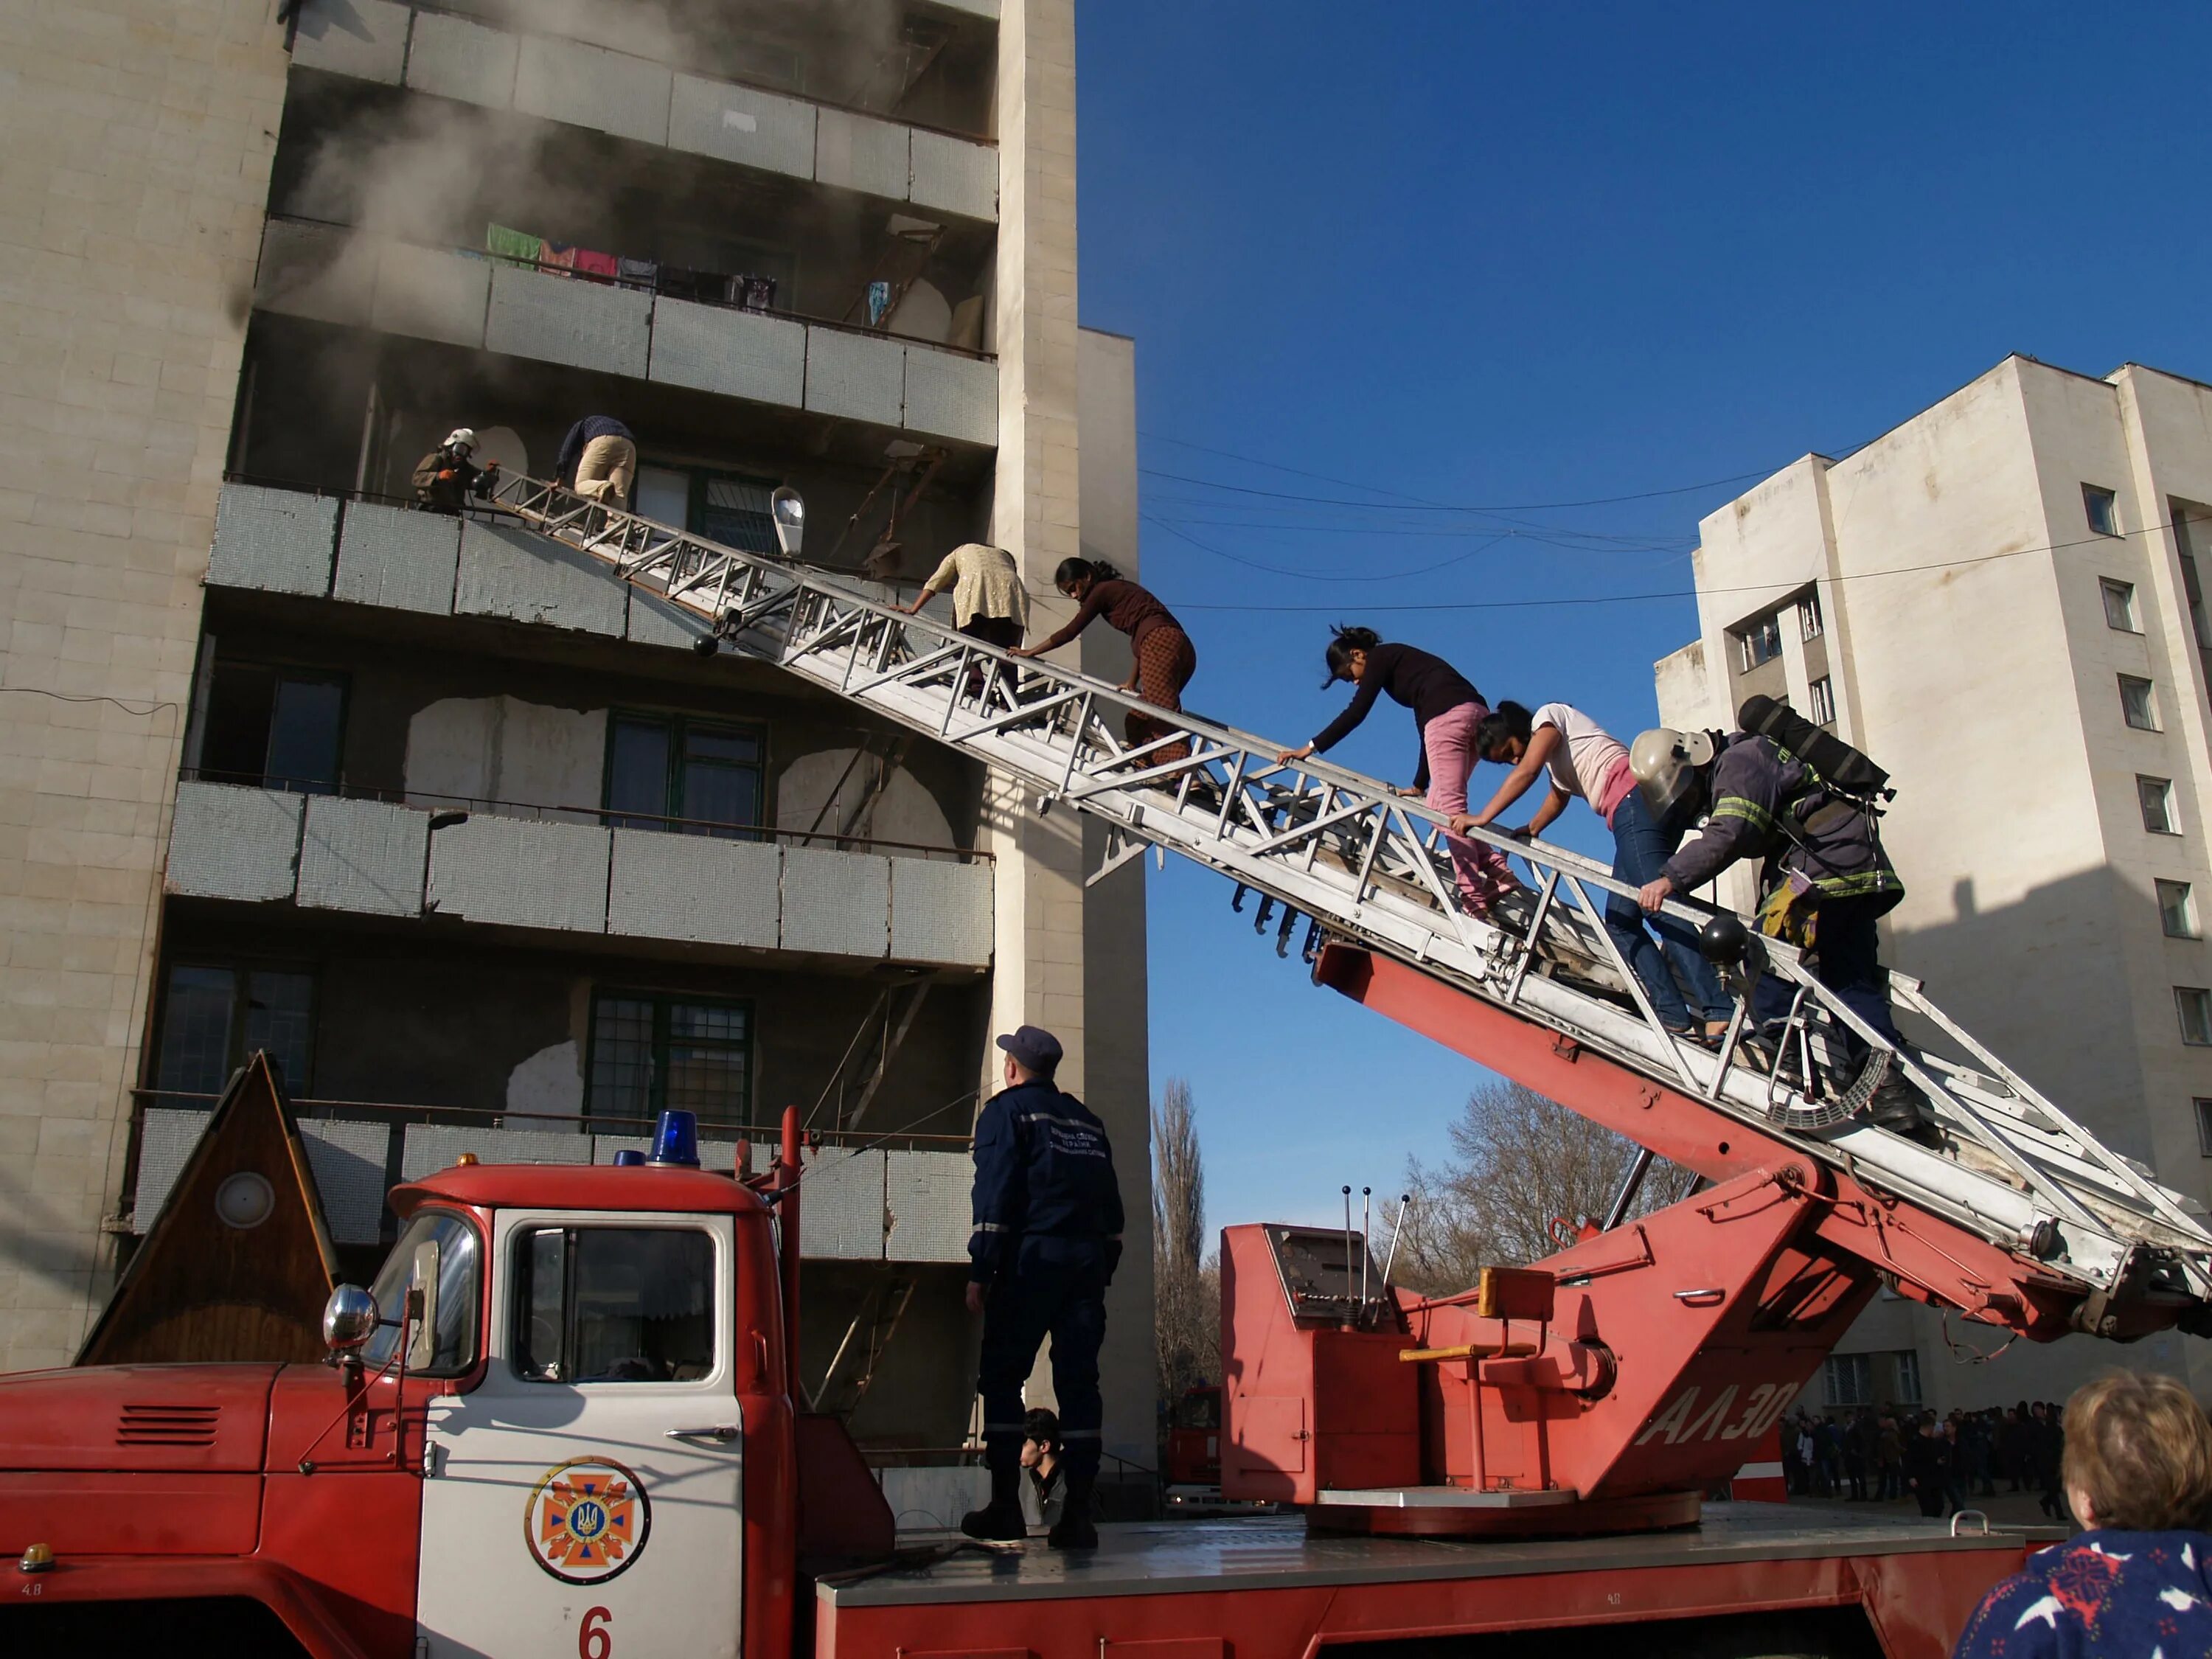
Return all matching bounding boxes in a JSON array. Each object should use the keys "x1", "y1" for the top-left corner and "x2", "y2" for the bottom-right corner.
[{"x1": 1783, "y1": 1400, "x2": 2066, "y2": 1520}]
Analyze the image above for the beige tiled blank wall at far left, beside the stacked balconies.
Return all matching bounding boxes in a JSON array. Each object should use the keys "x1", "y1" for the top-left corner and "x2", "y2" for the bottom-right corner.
[{"x1": 0, "y1": 0, "x2": 285, "y2": 1369}]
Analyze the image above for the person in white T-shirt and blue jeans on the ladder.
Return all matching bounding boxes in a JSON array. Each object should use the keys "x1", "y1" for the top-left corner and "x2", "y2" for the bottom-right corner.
[{"x1": 1451, "y1": 701, "x2": 1730, "y2": 1046}]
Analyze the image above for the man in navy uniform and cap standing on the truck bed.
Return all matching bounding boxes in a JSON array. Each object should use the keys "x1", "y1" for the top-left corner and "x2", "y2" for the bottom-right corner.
[{"x1": 960, "y1": 1026, "x2": 1121, "y2": 1548}]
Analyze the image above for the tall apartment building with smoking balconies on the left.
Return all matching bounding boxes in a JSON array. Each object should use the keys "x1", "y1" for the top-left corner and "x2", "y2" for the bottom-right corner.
[{"x1": 0, "y1": 0, "x2": 1155, "y2": 1504}]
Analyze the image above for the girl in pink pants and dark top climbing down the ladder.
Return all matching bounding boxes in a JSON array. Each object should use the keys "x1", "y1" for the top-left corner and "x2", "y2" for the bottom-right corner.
[{"x1": 1276, "y1": 628, "x2": 1520, "y2": 916}]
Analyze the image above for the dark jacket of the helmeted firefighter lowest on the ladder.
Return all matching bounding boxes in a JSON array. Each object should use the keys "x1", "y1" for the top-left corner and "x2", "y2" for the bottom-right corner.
[{"x1": 1666, "y1": 732, "x2": 1905, "y2": 911}]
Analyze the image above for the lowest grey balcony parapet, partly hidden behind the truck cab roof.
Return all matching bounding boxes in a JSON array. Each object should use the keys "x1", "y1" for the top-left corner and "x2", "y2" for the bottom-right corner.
[{"x1": 131, "y1": 1091, "x2": 975, "y2": 1263}]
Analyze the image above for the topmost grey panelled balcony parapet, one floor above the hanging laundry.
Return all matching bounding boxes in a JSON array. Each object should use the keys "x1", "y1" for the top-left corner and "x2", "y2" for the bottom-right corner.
[{"x1": 292, "y1": 0, "x2": 998, "y2": 221}]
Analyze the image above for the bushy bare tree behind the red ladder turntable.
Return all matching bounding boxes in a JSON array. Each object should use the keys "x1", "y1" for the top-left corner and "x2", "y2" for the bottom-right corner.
[{"x1": 1391, "y1": 1079, "x2": 1694, "y2": 1292}]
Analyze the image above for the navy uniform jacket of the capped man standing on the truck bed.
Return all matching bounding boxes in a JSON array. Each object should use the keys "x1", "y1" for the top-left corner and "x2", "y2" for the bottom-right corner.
[{"x1": 969, "y1": 1079, "x2": 1121, "y2": 1283}]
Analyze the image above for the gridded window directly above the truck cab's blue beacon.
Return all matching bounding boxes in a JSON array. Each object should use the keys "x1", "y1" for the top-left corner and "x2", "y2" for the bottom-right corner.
[{"x1": 586, "y1": 991, "x2": 752, "y2": 1124}]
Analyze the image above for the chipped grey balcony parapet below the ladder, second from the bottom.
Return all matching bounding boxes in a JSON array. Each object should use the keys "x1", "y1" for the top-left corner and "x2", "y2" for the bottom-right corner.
[{"x1": 166, "y1": 779, "x2": 993, "y2": 969}]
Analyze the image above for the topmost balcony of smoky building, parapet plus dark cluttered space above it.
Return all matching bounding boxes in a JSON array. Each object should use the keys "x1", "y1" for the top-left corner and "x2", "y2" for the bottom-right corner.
[{"x1": 292, "y1": 0, "x2": 998, "y2": 219}]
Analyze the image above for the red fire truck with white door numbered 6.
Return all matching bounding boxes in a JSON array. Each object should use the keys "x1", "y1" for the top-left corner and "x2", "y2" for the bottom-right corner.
[{"x1": 0, "y1": 1053, "x2": 2177, "y2": 1659}]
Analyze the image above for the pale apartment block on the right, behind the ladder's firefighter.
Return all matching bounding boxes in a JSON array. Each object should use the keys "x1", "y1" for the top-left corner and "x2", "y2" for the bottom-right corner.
[{"x1": 1657, "y1": 356, "x2": 2212, "y2": 1409}]
